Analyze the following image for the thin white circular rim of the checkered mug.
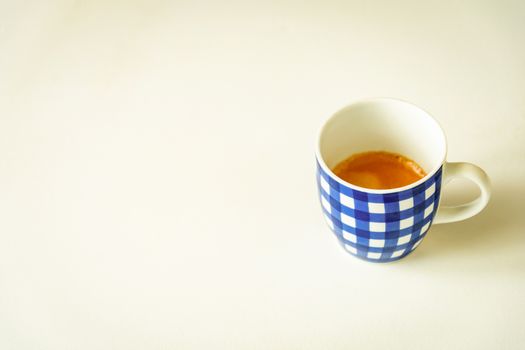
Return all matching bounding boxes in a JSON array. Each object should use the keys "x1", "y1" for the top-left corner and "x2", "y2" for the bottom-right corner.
[{"x1": 315, "y1": 97, "x2": 448, "y2": 194}]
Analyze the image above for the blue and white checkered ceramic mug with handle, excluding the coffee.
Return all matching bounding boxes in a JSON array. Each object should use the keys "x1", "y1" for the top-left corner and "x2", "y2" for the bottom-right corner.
[{"x1": 316, "y1": 98, "x2": 490, "y2": 262}]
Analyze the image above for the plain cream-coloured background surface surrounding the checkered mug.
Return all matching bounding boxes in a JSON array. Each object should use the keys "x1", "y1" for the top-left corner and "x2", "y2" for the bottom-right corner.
[{"x1": 0, "y1": 1, "x2": 525, "y2": 350}]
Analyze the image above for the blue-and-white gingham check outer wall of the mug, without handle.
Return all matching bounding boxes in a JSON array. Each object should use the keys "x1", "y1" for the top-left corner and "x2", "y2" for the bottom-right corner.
[{"x1": 317, "y1": 163, "x2": 442, "y2": 262}]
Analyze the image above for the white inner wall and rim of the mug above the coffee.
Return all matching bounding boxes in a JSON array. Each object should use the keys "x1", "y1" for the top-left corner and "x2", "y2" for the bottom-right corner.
[{"x1": 317, "y1": 98, "x2": 447, "y2": 193}]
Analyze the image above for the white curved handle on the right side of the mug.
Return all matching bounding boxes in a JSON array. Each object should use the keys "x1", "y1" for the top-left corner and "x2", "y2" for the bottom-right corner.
[{"x1": 434, "y1": 162, "x2": 490, "y2": 224}]
